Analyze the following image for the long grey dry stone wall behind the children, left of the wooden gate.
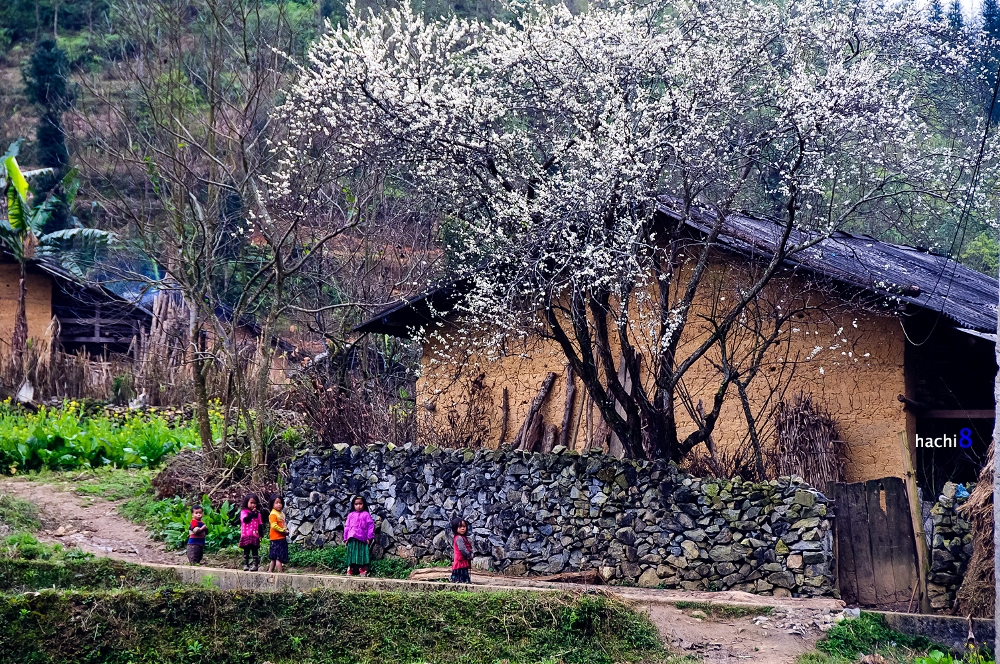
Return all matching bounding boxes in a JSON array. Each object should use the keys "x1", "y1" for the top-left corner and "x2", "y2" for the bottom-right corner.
[{"x1": 286, "y1": 446, "x2": 835, "y2": 596}]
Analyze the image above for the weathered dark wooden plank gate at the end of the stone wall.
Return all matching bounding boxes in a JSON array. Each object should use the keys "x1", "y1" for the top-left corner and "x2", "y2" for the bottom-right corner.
[{"x1": 830, "y1": 477, "x2": 920, "y2": 611}]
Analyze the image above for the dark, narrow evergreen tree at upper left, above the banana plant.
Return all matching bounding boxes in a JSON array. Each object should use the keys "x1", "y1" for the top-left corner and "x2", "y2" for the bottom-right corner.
[{"x1": 23, "y1": 39, "x2": 73, "y2": 171}]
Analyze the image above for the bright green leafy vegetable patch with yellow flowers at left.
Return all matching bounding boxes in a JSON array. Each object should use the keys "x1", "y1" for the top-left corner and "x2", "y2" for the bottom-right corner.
[{"x1": 0, "y1": 400, "x2": 218, "y2": 474}]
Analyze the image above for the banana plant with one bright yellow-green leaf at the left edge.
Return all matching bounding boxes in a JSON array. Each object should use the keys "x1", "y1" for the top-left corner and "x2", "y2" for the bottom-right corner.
[{"x1": 0, "y1": 140, "x2": 114, "y2": 374}]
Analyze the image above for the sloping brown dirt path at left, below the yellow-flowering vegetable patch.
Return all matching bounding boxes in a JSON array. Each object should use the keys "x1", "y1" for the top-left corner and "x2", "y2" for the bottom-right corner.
[{"x1": 0, "y1": 478, "x2": 181, "y2": 564}]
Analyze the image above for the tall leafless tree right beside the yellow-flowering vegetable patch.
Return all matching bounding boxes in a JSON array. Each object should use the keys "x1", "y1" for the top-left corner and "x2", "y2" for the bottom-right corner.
[{"x1": 76, "y1": 0, "x2": 320, "y2": 460}]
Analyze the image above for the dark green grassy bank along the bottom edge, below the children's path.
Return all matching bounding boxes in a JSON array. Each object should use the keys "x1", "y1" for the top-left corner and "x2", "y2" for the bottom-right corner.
[{"x1": 0, "y1": 587, "x2": 668, "y2": 664}]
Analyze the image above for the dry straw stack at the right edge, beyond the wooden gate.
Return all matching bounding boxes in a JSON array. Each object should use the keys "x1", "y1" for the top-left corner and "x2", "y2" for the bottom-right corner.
[{"x1": 954, "y1": 443, "x2": 995, "y2": 618}]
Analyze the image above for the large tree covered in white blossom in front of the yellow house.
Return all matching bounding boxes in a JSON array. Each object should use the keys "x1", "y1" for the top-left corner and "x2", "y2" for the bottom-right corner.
[{"x1": 269, "y1": 0, "x2": 992, "y2": 459}]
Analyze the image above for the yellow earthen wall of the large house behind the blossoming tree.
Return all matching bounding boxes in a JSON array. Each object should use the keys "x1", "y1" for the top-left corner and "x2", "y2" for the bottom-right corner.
[{"x1": 417, "y1": 268, "x2": 906, "y2": 482}]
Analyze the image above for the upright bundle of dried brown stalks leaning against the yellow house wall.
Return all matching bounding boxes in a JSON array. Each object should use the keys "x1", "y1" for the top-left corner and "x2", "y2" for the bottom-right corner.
[{"x1": 774, "y1": 392, "x2": 844, "y2": 490}]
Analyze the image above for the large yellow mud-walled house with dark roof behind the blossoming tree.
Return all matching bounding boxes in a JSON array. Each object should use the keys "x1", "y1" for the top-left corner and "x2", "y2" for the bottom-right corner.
[{"x1": 357, "y1": 208, "x2": 997, "y2": 495}]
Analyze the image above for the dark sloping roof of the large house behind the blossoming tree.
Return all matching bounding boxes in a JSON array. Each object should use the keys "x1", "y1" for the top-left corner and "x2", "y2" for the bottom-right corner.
[{"x1": 354, "y1": 201, "x2": 998, "y2": 337}]
